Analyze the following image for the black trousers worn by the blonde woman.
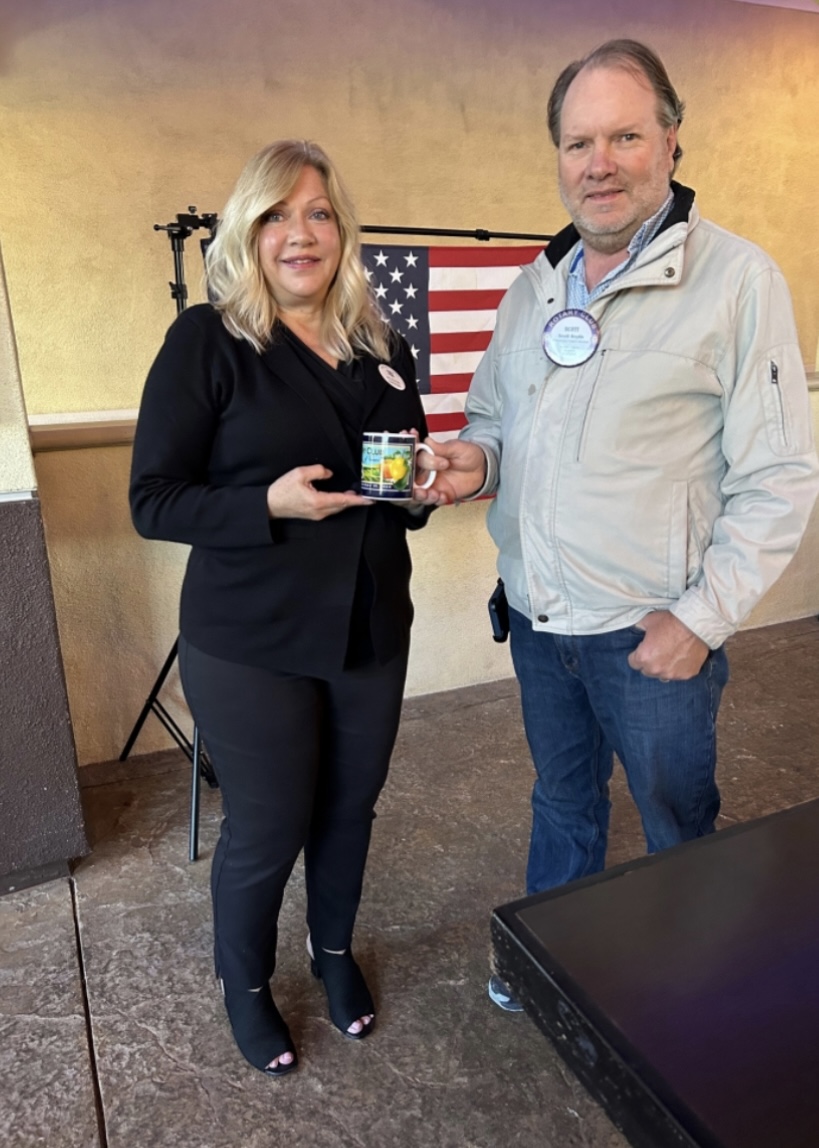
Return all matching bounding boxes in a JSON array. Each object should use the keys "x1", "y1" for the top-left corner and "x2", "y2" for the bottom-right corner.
[{"x1": 179, "y1": 638, "x2": 408, "y2": 988}]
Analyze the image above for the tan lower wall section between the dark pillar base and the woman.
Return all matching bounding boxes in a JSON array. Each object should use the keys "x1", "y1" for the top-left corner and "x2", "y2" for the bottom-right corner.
[{"x1": 36, "y1": 447, "x2": 191, "y2": 765}]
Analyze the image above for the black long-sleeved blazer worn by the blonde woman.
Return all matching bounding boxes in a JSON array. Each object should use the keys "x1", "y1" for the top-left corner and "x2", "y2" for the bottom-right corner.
[{"x1": 130, "y1": 303, "x2": 428, "y2": 676}]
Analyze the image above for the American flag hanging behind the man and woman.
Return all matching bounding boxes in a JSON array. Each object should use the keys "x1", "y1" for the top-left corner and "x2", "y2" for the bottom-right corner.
[{"x1": 362, "y1": 243, "x2": 542, "y2": 439}]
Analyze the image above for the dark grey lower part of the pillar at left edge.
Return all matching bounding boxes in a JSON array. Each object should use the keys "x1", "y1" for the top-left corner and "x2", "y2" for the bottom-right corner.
[{"x1": 0, "y1": 498, "x2": 88, "y2": 889}]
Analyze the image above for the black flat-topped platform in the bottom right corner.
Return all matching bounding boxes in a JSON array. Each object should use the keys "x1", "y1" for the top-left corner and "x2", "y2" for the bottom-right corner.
[{"x1": 492, "y1": 801, "x2": 819, "y2": 1148}]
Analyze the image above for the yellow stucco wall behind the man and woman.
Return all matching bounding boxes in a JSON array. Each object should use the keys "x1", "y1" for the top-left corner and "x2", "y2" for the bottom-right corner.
[{"x1": 0, "y1": 0, "x2": 819, "y2": 761}]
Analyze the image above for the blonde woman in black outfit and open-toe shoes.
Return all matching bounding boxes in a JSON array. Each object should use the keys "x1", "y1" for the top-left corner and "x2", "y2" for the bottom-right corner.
[{"x1": 130, "y1": 140, "x2": 428, "y2": 1076}]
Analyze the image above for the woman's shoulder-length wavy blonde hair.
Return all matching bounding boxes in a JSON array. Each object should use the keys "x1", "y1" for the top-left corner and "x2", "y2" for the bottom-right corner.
[{"x1": 206, "y1": 140, "x2": 393, "y2": 362}]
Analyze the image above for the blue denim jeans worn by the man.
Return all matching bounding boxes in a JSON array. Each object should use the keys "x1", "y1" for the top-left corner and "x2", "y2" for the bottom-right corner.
[{"x1": 509, "y1": 610, "x2": 728, "y2": 894}]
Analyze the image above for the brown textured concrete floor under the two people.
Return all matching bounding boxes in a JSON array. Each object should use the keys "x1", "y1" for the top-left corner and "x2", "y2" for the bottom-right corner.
[{"x1": 0, "y1": 619, "x2": 819, "y2": 1148}]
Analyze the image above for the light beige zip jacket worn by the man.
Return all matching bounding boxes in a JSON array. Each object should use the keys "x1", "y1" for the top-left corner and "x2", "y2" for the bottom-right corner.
[{"x1": 462, "y1": 192, "x2": 818, "y2": 649}]
